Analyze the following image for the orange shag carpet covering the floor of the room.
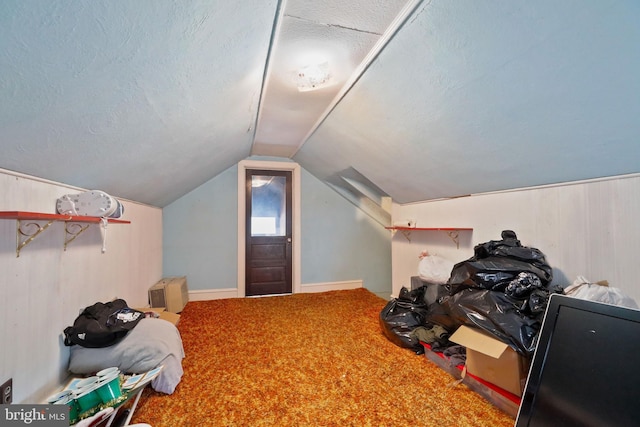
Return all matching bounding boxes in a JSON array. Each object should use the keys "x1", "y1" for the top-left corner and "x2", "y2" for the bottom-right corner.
[{"x1": 132, "y1": 289, "x2": 514, "y2": 427}]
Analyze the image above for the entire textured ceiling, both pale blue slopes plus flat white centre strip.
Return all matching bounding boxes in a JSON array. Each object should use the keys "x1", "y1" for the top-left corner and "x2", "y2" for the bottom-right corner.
[{"x1": 0, "y1": 0, "x2": 640, "y2": 213}]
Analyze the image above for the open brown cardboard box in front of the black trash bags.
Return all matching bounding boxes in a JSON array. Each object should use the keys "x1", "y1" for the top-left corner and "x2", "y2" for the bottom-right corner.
[{"x1": 449, "y1": 326, "x2": 529, "y2": 396}]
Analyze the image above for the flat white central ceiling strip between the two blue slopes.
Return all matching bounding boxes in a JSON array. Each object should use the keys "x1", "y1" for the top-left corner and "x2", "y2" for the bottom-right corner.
[{"x1": 252, "y1": 0, "x2": 412, "y2": 157}]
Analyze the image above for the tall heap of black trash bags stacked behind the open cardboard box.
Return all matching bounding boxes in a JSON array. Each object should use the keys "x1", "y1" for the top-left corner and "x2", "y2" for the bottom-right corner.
[{"x1": 426, "y1": 230, "x2": 562, "y2": 358}]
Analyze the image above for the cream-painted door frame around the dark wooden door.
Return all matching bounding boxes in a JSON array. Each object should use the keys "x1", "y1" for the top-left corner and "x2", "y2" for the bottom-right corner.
[{"x1": 238, "y1": 160, "x2": 301, "y2": 298}]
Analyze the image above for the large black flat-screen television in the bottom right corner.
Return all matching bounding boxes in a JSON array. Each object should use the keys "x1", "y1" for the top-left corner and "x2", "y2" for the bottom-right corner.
[{"x1": 515, "y1": 294, "x2": 640, "y2": 427}]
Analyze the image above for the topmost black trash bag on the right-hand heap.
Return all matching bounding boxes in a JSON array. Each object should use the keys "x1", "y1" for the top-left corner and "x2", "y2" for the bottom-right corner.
[{"x1": 446, "y1": 230, "x2": 553, "y2": 295}]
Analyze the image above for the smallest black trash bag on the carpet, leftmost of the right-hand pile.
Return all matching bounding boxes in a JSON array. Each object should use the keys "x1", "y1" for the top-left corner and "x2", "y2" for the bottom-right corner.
[{"x1": 379, "y1": 287, "x2": 427, "y2": 354}]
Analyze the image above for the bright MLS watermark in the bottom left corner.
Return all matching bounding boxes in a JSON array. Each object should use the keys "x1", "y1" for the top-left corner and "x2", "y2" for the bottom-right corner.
[{"x1": 0, "y1": 405, "x2": 69, "y2": 427}]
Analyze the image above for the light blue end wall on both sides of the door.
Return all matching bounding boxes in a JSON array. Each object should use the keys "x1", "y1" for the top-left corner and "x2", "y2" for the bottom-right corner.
[{"x1": 163, "y1": 160, "x2": 391, "y2": 296}]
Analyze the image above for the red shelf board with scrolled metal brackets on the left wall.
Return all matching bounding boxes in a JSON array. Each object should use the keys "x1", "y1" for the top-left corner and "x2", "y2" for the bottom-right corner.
[{"x1": 0, "y1": 211, "x2": 131, "y2": 258}]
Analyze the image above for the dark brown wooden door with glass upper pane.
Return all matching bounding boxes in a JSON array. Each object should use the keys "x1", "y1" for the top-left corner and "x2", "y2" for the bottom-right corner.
[{"x1": 245, "y1": 169, "x2": 292, "y2": 296}]
